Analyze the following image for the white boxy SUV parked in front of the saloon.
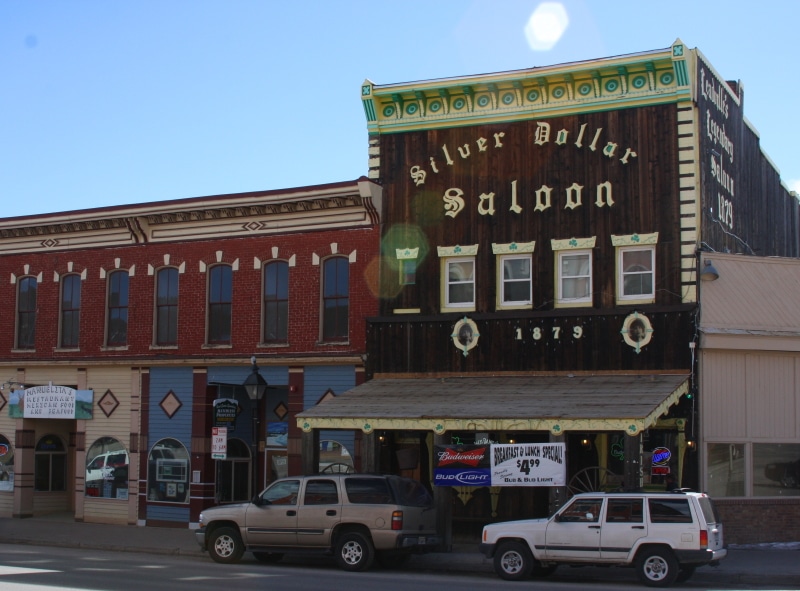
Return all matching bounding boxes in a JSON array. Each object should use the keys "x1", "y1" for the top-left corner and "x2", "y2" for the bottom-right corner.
[{"x1": 480, "y1": 491, "x2": 727, "y2": 587}]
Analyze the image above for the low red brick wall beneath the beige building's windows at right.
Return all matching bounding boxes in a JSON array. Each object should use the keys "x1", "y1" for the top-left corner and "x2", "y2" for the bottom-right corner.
[{"x1": 714, "y1": 497, "x2": 800, "y2": 544}]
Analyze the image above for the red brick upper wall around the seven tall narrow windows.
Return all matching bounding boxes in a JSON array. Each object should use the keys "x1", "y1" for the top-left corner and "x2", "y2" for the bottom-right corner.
[{"x1": 0, "y1": 228, "x2": 379, "y2": 364}]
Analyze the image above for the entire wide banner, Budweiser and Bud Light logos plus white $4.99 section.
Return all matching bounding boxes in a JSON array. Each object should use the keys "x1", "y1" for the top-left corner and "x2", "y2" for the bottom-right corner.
[{"x1": 433, "y1": 443, "x2": 567, "y2": 486}]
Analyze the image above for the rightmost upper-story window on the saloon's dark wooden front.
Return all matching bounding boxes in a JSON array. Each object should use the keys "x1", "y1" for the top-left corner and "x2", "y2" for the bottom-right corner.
[{"x1": 611, "y1": 232, "x2": 658, "y2": 304}]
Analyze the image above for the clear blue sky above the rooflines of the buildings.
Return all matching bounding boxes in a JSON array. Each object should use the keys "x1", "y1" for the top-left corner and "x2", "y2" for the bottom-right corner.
[{"x1": 0, "y1": 0, "x2": 800, "y2": 217}]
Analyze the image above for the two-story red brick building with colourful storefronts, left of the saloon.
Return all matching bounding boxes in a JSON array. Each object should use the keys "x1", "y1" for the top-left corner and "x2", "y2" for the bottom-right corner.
[{"x1": 0, "y1": 178, "x2": 381, "y2": 527}]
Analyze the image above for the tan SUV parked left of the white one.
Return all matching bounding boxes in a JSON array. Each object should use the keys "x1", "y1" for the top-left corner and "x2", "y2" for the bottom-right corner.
[{"x1": 195, "y1": 474, "x2": 441, "y2": 571}]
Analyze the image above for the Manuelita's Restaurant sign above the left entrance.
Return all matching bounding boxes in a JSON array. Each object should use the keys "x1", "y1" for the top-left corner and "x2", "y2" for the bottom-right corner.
[{"x1": 8, "y1": 384, "x2": 94, "y2": 419}]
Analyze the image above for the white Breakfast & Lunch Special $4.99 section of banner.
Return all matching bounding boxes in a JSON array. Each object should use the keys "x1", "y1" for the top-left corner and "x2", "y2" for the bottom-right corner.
[{"x1": 491, "y1": 443, "x2": 567, "y2": 486}]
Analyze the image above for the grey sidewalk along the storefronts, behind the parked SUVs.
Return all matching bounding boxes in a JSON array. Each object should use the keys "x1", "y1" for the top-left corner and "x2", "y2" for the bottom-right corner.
[{"x1": 0, "y1": 514, "x2": 800, "y2": 589}]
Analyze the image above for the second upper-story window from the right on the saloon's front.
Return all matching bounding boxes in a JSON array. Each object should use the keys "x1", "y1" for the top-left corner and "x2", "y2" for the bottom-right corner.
[{"x1": 551, "y1": 237, "x2": 596, "y2": 308}]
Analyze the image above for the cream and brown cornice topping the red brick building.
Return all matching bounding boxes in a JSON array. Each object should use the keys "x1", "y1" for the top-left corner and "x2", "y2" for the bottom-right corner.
[{"x1": 0, "y1": 178, "x2": 381, "y2": 255}]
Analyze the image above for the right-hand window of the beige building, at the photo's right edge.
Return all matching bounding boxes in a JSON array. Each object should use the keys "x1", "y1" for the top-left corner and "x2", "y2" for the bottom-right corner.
[{"x1": 753, "y1": 443, "x2": 800, "y2": 497}]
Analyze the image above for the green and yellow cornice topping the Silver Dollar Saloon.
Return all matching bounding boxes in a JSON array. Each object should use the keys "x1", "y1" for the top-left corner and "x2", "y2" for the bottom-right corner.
[{"x1": 361, "y1": 40, "x2": 696, "y2": 134}]
